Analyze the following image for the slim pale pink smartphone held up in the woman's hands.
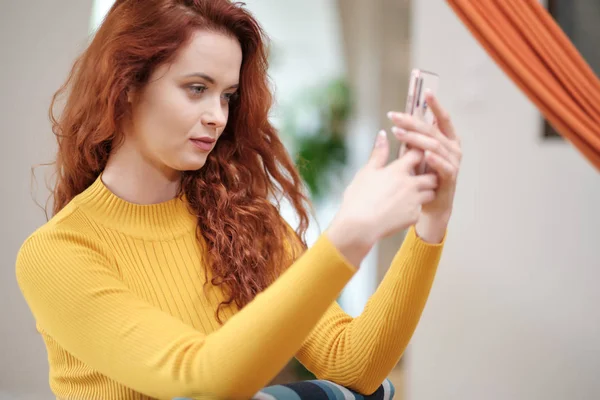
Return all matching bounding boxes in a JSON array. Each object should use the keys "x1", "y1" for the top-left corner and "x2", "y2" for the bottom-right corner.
[{"x1": 400, "y1": 68, "x2": 440, "y2": 174}]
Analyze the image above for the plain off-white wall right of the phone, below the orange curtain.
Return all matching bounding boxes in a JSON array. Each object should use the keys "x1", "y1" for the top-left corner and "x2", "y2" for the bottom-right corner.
[{"x1": 407, "y1": 0, "x2": 600, "y2": 400}]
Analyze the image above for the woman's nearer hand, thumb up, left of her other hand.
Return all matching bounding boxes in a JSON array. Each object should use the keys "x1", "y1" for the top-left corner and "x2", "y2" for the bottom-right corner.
[{"x1": 326, "y1": 131, "x2": 437, "y2": 268}]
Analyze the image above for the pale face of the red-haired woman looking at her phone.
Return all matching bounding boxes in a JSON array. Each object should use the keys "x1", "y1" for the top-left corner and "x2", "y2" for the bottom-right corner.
[{"x1": 126, "y1": 31, "x2": 242, "y2": 172}]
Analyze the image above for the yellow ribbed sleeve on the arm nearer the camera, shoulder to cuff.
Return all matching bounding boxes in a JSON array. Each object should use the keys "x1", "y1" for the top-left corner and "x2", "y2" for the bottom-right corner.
[{"x1": 16, "y1": 229, "x2": 356, "y2": 399}]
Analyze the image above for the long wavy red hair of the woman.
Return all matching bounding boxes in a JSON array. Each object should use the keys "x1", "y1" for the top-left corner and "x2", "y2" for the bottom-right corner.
[{"x1": 50, "y1": 0, "x2": 309, "y2": 322}]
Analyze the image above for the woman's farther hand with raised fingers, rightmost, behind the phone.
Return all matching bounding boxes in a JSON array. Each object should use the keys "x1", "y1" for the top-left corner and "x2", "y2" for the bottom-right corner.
[{"x1": 388, "y1": 93, "x2": 462, "y2": 243}]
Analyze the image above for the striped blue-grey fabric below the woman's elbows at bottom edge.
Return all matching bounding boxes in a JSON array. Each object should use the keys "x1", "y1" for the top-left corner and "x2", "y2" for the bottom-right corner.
[{"x1": 252, "y1": 379, "x2": 395, "y2": 400}]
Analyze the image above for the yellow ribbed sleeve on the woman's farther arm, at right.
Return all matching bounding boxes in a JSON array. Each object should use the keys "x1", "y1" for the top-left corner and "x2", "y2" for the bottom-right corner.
[{"x1": 297, "y1": 227, "x2": 443, "y2": 394}]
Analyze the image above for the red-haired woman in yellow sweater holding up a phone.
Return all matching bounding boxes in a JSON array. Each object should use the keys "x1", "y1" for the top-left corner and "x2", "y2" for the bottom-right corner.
[{"x1": 17, "y1": 0, "x2": 460, "y2": 400}]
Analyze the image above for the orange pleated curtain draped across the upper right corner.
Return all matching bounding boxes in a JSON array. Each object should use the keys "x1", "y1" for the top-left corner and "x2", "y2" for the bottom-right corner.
[{"x1": 447, "y1": 0, "x2": 600, "y2": 170}]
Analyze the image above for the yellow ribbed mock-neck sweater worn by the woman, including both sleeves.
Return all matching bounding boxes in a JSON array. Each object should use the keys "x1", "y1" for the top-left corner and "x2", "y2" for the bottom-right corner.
[{"x1": 16, "y1": 178, "x2": 442, "y2": 400}]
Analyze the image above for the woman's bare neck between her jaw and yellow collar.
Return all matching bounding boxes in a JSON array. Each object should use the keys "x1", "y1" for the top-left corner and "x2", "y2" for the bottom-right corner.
[{"x1": 102, "y1": 140, "x2": 181, "y2": 204}]
